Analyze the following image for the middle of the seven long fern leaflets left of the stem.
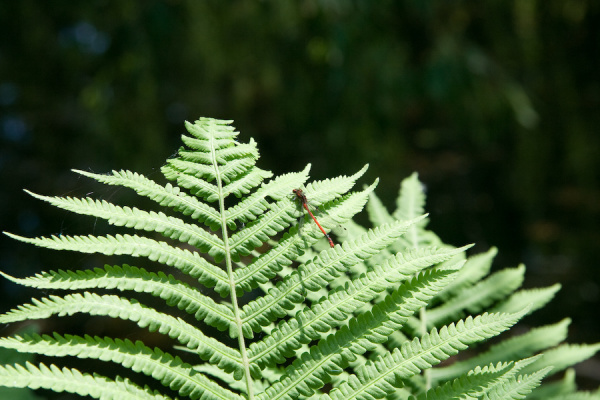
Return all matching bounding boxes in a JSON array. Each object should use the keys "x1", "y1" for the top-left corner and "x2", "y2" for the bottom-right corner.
[{"x1": 0, "y1": 265, "x2": 236, "y2": 337}]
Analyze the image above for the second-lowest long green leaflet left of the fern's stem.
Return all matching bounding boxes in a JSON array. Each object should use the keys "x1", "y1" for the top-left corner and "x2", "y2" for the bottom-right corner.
[{"x1": 0, "y1": 333, "x2": 244, "y2": 399}]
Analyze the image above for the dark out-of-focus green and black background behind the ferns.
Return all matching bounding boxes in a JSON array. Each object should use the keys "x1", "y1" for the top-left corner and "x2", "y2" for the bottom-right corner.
[{"x1": 0, "y1": 0, "x2": 600, "y2": 387}]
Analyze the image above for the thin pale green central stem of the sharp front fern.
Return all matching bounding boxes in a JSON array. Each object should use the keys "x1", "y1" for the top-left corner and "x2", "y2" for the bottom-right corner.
[{"x1": 211, "y1": 140, "x2": 254, "y2": 400}]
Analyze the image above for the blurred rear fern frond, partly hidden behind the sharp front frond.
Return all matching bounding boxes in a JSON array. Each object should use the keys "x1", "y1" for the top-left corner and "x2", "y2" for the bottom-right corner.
[{"x1": 360, "y1": 174, "x2": 600, "y2": 399}]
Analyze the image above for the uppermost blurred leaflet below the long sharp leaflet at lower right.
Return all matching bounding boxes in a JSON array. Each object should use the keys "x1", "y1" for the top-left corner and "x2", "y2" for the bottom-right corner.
[{"x1": 431, "y1": 318, "x2": 571, "y2": 382}]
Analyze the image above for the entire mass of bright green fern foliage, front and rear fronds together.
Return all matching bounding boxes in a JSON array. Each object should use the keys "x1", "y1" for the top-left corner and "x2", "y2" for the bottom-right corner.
[{"x1": 0, "y1": 118, "x2": 597, "y2": 400}]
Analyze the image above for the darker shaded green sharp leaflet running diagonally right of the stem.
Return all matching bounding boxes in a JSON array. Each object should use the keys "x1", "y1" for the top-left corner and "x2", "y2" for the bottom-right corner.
[{"x1": 259, "y1": 270, "x2": 460, "y2": 400}]
